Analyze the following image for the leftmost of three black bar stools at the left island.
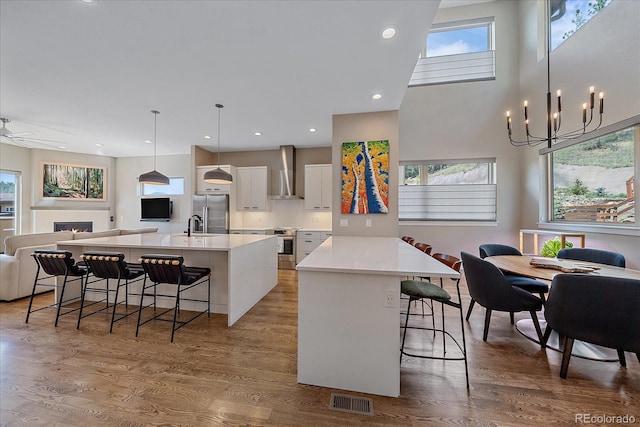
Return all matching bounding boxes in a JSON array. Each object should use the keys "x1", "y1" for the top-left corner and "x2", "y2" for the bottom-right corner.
[{"x1": 25, "y1": 249, "x2": 87, "y2": 326}]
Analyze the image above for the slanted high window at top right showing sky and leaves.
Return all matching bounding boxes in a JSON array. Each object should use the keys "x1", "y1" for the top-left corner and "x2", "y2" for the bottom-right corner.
[{"x1": 549, "y1": 0, "x2": 611, "y2": 50}]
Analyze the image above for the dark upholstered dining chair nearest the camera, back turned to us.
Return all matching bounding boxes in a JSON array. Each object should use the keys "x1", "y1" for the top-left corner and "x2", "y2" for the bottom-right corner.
[{"x1": 544, "y1": 274, "x2": 640, "y2": 378}]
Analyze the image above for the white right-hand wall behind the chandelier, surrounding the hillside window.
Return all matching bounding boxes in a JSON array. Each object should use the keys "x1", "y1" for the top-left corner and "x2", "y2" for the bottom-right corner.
[{"x1": 513, "y1": 1, "x2": 640, "y2": 269}]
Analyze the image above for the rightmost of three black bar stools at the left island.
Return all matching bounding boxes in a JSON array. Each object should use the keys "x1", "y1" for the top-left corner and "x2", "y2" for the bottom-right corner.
[{"x1": 136, "y1": 254, "x2": 211, "y2": 342}]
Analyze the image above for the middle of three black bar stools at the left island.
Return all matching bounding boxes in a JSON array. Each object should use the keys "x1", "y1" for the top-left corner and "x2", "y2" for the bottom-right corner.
[{"x1": 76, "y1": 252, "x2": 144, "y2": 333}]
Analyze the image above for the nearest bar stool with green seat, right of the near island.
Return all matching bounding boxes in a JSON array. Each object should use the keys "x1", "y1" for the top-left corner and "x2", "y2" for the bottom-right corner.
[{"x1": 400, "y1": 253, "x2": 469, "y2": 388}]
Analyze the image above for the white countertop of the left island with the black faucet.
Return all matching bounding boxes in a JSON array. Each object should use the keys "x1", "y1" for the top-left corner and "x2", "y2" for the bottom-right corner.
[{"x1": 58, "y1": 233, "x2": 276, "y2": 251}]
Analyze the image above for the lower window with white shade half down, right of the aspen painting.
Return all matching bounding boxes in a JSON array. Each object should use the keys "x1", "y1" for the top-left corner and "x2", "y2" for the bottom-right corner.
[{"x1": 398, "y1": 159, "x2": 496, "y2": 221}]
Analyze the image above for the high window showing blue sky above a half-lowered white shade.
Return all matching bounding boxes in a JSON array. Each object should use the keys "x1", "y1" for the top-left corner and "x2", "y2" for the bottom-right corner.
[{"x1": 409, "y1": 18, "x2": 495, "y2": 87}]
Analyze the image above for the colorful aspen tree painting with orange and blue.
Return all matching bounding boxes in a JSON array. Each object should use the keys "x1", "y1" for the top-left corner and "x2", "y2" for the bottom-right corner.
[{"x1": 341, "y1": 140, "x2": 389, "y2": 214}]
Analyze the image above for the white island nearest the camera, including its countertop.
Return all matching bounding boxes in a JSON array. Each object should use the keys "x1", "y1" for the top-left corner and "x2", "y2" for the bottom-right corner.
[{"x1": 296, "y1": 236, "x2": 460, "y2": 397}]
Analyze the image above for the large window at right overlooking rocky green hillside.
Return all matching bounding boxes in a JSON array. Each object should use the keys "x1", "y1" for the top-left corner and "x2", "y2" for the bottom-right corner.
[{"x1": 550, "y1": 125, "x2": 640, "y2": 225}]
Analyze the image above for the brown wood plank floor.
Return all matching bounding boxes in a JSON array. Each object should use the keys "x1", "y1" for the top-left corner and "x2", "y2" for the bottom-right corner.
[{"x1": 0, "y1": 271, "x2": 640, "y2": 426}]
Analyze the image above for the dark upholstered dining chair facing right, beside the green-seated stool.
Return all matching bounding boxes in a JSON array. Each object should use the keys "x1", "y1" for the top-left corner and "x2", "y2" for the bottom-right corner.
[{"x1": 461, "y1": 252, "x2": 545, "y2": 348}]
